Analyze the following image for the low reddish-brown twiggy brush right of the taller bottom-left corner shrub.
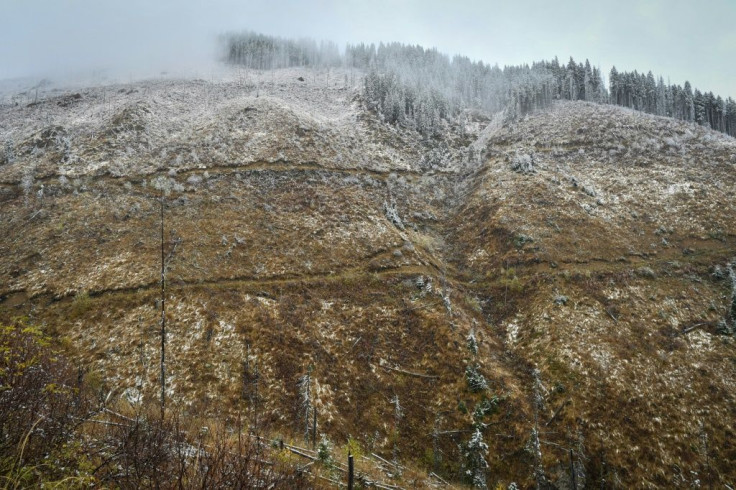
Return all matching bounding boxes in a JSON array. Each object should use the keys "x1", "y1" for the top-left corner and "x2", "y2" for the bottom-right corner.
[{"x1": 98, "y1": 414, "x2": 307, "y2": 488}]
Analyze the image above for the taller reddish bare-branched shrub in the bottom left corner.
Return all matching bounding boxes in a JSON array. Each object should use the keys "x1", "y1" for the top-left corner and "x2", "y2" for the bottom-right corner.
[{"x1": 0, "y1": 322, "x2": 88, "y2": 488}]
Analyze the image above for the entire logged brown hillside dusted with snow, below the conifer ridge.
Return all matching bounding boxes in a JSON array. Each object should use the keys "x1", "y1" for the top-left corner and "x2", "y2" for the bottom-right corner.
[{"x1": 0, "y1": 69, "x2": 736, "y2": 488}]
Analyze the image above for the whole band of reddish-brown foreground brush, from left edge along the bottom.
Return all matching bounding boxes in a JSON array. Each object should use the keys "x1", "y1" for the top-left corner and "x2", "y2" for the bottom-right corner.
[{"x1": 0, "y1": 323, "x2": 312, "y2": 488}]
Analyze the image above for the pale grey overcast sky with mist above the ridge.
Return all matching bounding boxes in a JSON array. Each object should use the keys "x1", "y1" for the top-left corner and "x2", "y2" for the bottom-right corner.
[{"x1": 0, "y1": 0, "x2": 736, "y2": 97}]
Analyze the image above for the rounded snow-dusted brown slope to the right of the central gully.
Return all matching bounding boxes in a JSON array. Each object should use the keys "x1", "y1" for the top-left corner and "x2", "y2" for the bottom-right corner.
[{"x1": 448, "y1": 104, "x2": 736, "y2": 487}]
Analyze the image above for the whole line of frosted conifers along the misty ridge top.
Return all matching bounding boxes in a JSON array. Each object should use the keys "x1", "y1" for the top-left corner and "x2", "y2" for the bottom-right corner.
[{"x1": 221, "y1": 32, "x2": 736, "y2": 136}]
